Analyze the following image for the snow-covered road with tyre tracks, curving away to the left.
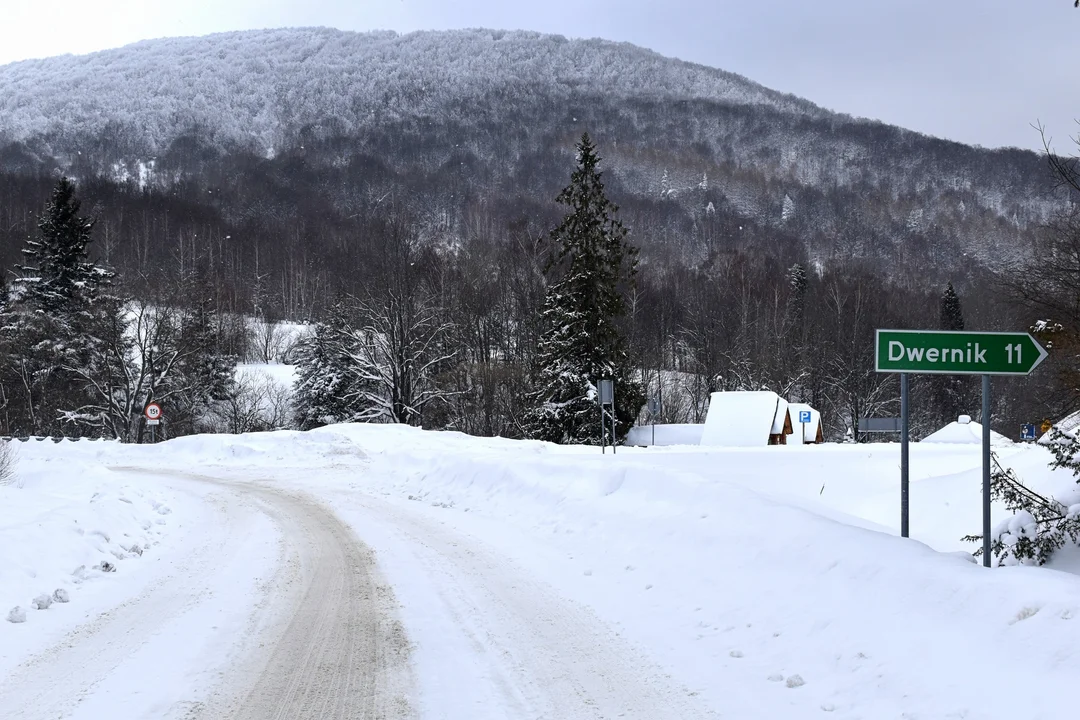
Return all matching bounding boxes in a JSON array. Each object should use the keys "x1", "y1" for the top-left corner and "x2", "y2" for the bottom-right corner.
[{"x1": 6, "y1": 467, "x2": 714, "y2": 720}]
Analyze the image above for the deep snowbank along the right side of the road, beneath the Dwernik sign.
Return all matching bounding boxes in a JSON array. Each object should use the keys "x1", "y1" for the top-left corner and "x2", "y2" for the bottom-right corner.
[{"x1": 135, "y1": 425, "x2": 1080, "y2": 718}]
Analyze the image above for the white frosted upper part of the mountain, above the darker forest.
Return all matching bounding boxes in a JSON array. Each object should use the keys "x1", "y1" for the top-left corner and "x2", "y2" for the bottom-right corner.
[{"x1": 0, "y1": 28, "x2": 823, "y2": 151}]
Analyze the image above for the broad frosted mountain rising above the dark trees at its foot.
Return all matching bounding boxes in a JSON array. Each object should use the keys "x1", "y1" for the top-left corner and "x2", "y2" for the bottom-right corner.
[{"x1": 0, "y1": 28, "x2": 1061, "y2": 282}]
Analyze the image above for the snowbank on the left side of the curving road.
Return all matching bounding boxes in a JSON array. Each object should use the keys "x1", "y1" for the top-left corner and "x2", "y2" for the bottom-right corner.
[{"x1": 0, "y1": 441, "x2": 201, "y2": 679}]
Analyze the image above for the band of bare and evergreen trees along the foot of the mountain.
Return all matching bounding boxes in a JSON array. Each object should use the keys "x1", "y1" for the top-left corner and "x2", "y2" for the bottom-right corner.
[{"x1": 0, "y1": 131, "x2": 1080, "y2": 440}]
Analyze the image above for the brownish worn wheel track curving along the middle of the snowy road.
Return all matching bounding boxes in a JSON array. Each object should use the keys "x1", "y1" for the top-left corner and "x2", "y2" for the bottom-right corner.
[{"x1": 192, "y1": 478, "x2": 413, "y2": 720}]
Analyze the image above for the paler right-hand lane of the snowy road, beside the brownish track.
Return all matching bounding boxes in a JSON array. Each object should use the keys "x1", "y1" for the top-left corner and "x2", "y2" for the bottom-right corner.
[{"x1": 324, "y1": 491, "x2": 719, "y2": 720}]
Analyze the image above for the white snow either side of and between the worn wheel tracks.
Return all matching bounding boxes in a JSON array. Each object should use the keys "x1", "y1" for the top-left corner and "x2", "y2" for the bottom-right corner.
[{"x1": 0, "y1": 425, "x2": 1080, "y2": 720}]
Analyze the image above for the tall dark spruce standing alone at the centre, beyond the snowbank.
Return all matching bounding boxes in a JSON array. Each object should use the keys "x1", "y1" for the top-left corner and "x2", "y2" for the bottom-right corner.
[{"x1": 525, "y1": 133, "x2": 644, "y2": 444}]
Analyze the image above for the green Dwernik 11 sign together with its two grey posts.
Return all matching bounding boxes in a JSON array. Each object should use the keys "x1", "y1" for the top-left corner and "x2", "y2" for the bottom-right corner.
[{"x1": 875, "y1": 330, "x2": 1047, "y2": 568}]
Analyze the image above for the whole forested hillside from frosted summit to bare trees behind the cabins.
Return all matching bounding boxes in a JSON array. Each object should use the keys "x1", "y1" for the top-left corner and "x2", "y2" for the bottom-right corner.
[{"x1": 0, "y1": 29, "x2": 1067, "y2": 437}]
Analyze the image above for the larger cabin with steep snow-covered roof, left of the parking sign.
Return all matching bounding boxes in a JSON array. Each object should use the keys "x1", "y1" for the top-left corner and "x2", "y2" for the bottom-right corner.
[{"x1": 701, "y1": 391, "x2": 792, "y2": 448}]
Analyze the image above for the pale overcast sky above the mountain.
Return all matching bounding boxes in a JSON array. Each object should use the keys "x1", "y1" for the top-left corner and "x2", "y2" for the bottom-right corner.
[{"x1": 0, "y1": 0, "x2": 1080, "y2": 149}]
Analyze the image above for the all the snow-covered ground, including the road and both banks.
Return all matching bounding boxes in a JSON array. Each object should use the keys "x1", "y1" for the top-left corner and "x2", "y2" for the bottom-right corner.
[{"x1": 0, "y1": 425, "x2": 1080, "y2": 720}]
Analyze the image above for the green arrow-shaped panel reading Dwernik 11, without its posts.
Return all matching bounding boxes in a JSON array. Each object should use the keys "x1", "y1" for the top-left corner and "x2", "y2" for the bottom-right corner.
[{"x1": 876, "y1": 330, "x2": 1047, "y2": 375}]
